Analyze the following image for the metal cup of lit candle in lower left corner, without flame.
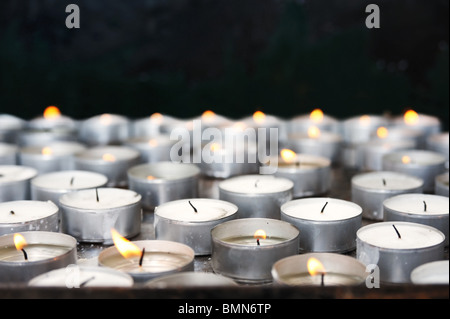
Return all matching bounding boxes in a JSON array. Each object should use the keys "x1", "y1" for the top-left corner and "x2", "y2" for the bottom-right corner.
[{"x1": 0, "y1": 231, "x2": 77, "y2": 283}]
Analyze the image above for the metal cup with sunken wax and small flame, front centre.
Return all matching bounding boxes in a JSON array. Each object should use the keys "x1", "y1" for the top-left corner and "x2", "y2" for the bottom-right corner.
[{"x1": 211, "y1": 218, "x2": 299, "y2": 283}]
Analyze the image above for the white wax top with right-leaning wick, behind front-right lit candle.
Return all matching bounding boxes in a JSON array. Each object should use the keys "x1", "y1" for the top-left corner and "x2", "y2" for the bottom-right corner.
[{"x1": 281, "y1": 197, "x2": 362, "y2": 221}]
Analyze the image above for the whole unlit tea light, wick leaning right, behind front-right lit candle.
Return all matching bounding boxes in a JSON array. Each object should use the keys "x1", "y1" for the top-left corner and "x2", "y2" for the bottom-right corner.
[{"x1": 281, "y1": 197, "x2": 362, "y2": 253}]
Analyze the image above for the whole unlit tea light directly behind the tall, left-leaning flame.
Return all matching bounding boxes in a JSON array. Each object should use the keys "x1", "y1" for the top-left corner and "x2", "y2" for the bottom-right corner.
[{"x1": 59, "y1": 188, "x2": 142, "y2": 245}]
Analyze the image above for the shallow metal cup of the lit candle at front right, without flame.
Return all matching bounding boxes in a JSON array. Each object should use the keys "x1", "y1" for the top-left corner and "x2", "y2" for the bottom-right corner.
[{"x1": 271, "y1": 253, "x2": 369, "y2": 286}]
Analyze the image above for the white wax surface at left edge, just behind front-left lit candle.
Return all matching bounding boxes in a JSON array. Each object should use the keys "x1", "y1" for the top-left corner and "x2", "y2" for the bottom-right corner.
[{"x1": 0, "y1": 200, "x2": 58, "y2": 224}]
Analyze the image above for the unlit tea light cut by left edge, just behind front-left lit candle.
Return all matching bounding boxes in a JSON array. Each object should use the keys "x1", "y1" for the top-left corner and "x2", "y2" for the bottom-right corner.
[{"x1": 0, "y1": 200, "x2": 59, "y2": 235}]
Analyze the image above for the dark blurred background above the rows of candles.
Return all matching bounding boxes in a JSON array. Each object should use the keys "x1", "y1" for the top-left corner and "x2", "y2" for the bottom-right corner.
[{"x1": 0, "y1": 0, "x2": 449, "y2": 125}]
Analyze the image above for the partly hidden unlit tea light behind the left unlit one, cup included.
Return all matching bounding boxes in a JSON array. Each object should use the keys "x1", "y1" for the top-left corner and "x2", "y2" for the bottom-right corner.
[{"x1": 31, "y1": 170, "x2": 108, "y2": 205}]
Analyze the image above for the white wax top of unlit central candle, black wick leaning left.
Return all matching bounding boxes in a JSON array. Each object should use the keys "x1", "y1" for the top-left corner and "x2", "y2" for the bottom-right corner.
[{"x1": 155, "y1": 198, "x2": 238, "y2": 222}]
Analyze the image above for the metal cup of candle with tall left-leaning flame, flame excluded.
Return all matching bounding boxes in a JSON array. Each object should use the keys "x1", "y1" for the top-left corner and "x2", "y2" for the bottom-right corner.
[{"x1": 98, "y1": 240, "x2": 195, "y2": 283}]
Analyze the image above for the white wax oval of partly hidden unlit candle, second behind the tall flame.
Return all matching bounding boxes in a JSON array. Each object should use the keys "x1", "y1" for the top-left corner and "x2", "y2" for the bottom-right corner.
[{"x1": 31, "y1": 171, "x2": 108, "y2": 190}]
